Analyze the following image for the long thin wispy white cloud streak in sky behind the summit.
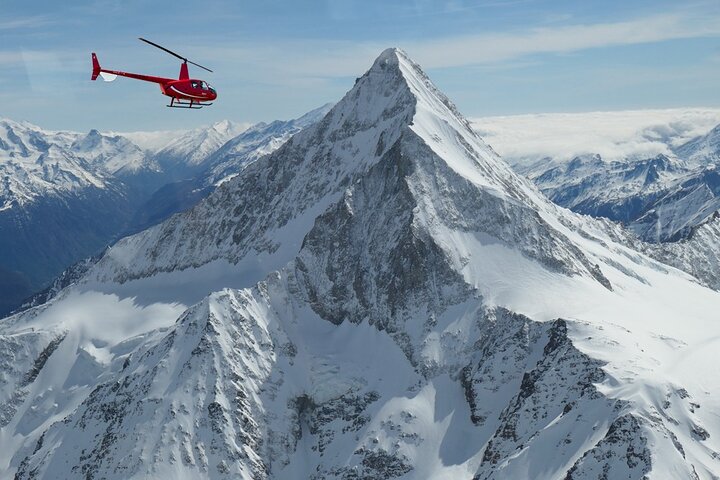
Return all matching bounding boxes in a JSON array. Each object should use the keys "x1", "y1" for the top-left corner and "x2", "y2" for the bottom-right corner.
[{"x1": 191, "y1": 10, "x2": 720, "y2": 77}]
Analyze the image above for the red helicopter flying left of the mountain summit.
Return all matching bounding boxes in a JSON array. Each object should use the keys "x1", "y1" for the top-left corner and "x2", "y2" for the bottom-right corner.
[{"x1": 91, "y1": 38, "x2": 217, "y2": 108}]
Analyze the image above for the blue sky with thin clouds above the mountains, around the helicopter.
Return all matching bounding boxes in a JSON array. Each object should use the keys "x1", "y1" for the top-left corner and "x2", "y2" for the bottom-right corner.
[{"x1": 0, "y1": 0, "x2": 720, "y2": 131}]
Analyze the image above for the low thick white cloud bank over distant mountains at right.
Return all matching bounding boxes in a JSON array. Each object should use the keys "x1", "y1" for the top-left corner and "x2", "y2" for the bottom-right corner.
[{"x1": 472, "y1": 108, "x2": 720, "y2": 162}]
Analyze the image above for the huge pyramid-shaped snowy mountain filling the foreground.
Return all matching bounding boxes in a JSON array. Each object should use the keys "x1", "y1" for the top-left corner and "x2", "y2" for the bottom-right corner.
[{"x1": 0, "y1": 49, "x2": 720, "y2": 479}]
